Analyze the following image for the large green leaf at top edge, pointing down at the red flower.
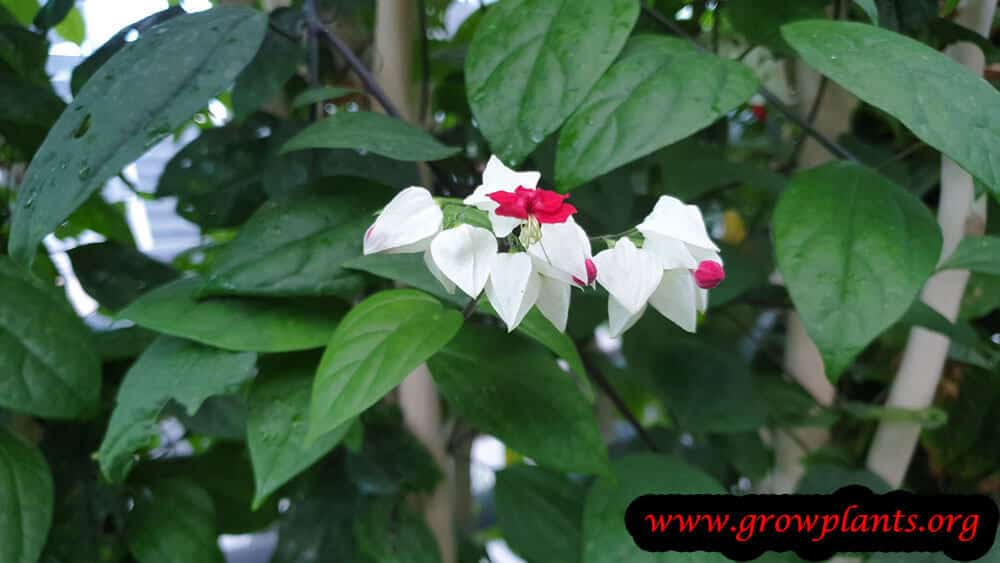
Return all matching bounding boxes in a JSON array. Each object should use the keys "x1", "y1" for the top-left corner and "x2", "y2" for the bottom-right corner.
[{"x1": 465, "y1": 0, "x2": 639, "y2": 163}]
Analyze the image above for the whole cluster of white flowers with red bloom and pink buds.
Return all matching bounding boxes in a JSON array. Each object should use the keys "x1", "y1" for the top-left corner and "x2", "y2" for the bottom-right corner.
[{"x1": 364, "y1": 157, "x2": 725, "y2": 336}]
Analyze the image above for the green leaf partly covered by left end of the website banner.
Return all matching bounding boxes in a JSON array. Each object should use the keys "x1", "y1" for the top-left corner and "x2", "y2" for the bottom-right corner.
[{"x1": 583, "y1": 454, "x2": 728, "y2": 563}]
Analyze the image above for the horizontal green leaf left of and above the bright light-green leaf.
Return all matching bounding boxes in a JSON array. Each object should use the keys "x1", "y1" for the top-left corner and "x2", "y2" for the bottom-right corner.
[{"x1": 120, "y1": 278, "x2": 343, "y2": 352}]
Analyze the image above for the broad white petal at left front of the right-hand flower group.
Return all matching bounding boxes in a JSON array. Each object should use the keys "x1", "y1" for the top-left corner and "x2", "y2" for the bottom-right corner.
[{"x1": 594, "y1": 237, "x2": 663, "y2": 313}]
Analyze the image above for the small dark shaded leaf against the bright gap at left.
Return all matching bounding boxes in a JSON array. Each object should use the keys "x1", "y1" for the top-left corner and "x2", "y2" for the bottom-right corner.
[{"x1": 68, "y1": 241, "x2": 177, "y2": 311}]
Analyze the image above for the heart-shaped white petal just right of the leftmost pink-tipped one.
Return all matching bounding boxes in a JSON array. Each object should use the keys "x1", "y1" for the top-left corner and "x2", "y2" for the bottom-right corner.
[{"x1": 431, "y1": 224, "x2": 497, "y2": 297}]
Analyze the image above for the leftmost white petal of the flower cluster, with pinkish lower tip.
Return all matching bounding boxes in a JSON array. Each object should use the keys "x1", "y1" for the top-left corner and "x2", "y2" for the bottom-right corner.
[{"x1": 364, "y1": 186, "x2": 444, "y2": 255}]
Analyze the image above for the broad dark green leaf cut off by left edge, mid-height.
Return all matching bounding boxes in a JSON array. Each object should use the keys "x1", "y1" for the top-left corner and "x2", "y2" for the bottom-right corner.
[{"x1": 0, "y1": 257, "x2": 101, "y2": 418}]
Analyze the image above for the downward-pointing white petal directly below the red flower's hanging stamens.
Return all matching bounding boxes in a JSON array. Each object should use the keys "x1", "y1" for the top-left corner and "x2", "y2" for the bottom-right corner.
[{"x1": 486, "y1": 252, "x2": 541, "y2": 332}]
